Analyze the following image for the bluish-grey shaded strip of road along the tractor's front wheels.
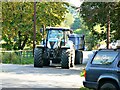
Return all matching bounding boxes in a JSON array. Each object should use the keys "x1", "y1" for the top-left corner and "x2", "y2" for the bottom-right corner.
[{"x1": 2, "y1": 64, "x2": 85, "y2": 75}]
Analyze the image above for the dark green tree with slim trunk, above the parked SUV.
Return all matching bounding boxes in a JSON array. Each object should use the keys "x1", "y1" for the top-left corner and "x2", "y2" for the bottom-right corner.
[{"x1": 80, "y1": 2, "x2": 120, "y2": 48}]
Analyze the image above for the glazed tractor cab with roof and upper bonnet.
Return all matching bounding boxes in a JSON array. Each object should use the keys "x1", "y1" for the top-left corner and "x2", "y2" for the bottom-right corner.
[{"x1": 44, "y1": 27, "x2": 70, "y2": 49}]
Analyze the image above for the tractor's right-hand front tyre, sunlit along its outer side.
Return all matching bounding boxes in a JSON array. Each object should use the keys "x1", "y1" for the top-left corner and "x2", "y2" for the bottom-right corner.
[{"x1": 61, "y1": 49, "x2": 71, "y2": 69}]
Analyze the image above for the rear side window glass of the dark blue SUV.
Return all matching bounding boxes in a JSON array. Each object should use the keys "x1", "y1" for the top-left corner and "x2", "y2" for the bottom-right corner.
[{"x1": 92, "y1": 51, "x2": 118, "y2": 65}]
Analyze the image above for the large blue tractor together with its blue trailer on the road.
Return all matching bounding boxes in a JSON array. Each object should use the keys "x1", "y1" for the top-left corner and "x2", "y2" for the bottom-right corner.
[{"x1": 34, "y1": 27, "x2": 84, "y2": 69}]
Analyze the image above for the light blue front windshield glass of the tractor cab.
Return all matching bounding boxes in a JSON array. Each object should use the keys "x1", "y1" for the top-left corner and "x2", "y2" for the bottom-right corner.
[{"x1": 48, "y1": 30, "x2": 63, "y2": 39}]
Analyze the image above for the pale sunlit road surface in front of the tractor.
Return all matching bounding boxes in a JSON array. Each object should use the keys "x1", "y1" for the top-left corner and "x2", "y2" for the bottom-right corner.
[{"x1": 0, "y1": 64, "x2": 85, "y2": 88}]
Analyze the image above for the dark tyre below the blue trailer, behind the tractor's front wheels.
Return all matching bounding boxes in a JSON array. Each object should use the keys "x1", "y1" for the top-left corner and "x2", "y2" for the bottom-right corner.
[{"x1": 75, "y1": 50, "x2": 83, "y2": 64}]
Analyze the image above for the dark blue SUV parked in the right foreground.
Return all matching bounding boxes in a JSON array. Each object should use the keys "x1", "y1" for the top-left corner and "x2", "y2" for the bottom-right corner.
[{"x1": 83, "y1": 40, "x2": 120, "y2": 90}]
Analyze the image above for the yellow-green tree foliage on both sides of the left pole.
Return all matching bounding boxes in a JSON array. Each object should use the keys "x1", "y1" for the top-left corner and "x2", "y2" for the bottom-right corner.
[{"x1": 2, "y1": 2, "x2": 68, "y2": 50}]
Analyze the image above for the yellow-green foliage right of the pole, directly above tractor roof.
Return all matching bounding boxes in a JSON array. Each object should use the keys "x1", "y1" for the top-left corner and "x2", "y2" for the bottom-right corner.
[{"x1": 37, "y1": 2, "x2": 68, "y2": 26}]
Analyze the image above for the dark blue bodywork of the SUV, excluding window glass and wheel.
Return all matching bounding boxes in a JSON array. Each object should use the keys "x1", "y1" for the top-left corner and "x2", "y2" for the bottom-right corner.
[{"x1": 83, "y1": 50, "x2": 120, "y2": 89}]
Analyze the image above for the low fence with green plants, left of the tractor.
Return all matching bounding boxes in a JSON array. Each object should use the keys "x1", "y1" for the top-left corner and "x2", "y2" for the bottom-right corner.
[{"x1": 0, "y1": 50, "x2": 33, "y2": 64}]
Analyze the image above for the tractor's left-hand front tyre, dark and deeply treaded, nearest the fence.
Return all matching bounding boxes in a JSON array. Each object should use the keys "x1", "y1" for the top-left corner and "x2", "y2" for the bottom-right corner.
[{"x1": 34, "y1": 48, "x2": 43, "y2": 67}]
